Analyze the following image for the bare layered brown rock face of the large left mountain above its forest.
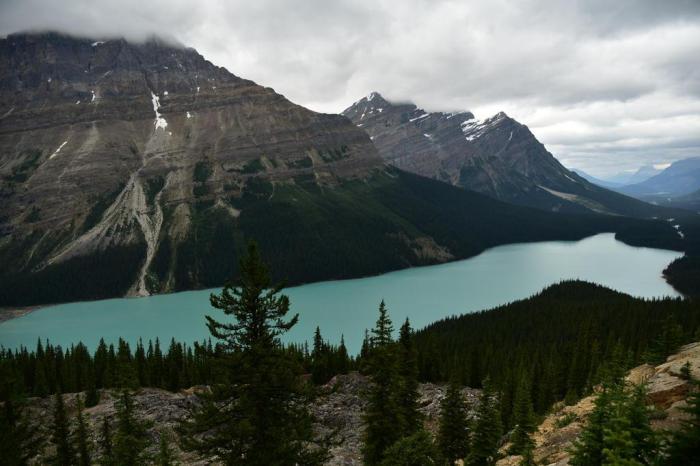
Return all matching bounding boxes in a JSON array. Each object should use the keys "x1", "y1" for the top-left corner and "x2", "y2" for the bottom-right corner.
[{"x1": 0, "y1": 34, "x2": 383, "y2": 302}]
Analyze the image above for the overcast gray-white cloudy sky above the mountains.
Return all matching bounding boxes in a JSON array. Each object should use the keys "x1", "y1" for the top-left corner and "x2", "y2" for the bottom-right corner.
[{"x1": 0, "y1": 0, "x2": 700, "y2": 175}]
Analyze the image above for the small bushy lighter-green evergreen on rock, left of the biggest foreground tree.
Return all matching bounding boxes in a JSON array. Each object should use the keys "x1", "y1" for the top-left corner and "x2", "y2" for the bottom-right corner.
[{"x1": 112, "y1": 389, "x2": 149, "y2": 466}]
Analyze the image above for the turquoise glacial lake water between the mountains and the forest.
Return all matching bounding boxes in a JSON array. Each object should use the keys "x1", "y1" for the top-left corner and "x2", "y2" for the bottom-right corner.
[{"x1": 0, "y1": 233, "x2": 682, "y2": 353}]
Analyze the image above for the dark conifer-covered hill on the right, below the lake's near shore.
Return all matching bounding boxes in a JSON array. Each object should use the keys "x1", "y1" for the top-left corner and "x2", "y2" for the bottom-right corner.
[{"x1": 416, "y1": 281, "x2": 700, "y2": 425}]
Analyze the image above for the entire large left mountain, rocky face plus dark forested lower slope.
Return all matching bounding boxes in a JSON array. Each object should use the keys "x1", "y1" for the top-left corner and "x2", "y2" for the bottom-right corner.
[{"x1": 0, "y1": 33, "x2": 678, "y2": 306}]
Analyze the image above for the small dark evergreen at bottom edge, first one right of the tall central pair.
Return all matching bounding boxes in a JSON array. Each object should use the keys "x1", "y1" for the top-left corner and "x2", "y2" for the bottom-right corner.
[{"x1": 437, "y1": 380, "x2": 469, "y2": 465}]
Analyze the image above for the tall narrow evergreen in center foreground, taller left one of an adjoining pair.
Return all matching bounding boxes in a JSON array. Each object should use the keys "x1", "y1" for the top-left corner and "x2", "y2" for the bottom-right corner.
[{"x1": 362, "y1": 301, "x2": 403, "y2": 466}]
